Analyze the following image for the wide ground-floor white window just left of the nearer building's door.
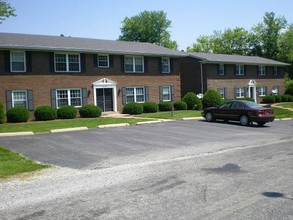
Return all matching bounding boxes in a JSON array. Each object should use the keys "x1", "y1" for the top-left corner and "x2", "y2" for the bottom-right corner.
[{"x1": 56, "y1": 89, "x2": 82, "y2": 108}]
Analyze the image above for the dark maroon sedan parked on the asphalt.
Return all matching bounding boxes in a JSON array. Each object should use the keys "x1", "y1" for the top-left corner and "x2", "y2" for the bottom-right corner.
[{"x1": 201, "y1": 100, "x2": 275, "y2": 126}]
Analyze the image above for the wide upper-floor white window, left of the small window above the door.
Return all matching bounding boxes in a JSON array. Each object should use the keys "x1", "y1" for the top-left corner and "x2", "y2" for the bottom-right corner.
[{"x1": 55, "y1": 53, "x2": 80, "y2": 72}]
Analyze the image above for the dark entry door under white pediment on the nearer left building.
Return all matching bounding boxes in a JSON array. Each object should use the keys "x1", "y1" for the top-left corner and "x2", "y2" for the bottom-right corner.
[{"x1": 96, "y1": 88, "x2": 113, "y2": 112}]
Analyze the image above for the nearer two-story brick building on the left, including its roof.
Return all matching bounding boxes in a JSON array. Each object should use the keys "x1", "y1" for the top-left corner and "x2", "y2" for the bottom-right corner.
[{"x1": 0, "y1": 33, "x2": 186, "y2": 111}]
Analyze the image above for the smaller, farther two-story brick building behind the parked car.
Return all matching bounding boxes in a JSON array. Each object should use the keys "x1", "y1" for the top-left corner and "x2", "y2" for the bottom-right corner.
[{"x1": 181, "y1": 53, "x2": 288, "y2": 102}]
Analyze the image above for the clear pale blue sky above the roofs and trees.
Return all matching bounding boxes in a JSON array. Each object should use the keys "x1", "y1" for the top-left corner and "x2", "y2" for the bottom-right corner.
[{"x1": 0, "y1": 0, "x2": 293, "y2": 50}]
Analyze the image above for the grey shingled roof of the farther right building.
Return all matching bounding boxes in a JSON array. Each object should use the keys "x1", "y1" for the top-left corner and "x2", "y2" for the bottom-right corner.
[{"x1": 189, "y1": 53, "x2": 290, "y2": 66}]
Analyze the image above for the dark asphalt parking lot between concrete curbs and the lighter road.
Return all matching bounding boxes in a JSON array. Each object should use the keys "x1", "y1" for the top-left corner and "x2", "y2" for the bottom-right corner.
[{"x1": 0, "y1": 120, "x2": 293, "y2": 169}]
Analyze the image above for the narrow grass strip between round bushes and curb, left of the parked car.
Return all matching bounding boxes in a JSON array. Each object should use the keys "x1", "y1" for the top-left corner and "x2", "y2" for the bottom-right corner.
[{"x1": 138, "y1": 110, "x2": 201, "y2": 119}]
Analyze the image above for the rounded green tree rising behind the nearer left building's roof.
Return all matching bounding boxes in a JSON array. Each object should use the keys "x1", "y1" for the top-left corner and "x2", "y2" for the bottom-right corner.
[{"x1": 119, "y1": 11, "x2": 178, "y2": 49}]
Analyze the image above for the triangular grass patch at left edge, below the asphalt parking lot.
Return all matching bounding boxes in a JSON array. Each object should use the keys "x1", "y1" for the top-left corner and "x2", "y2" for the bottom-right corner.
[{"x1": 0, "y1": 147, "x2": 50, "y2": 178}]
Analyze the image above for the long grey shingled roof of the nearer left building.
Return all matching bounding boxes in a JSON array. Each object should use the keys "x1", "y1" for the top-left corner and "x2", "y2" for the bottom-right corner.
[{"x1": 0, "y1": 33, "x2": 187, "y2": 57}]
